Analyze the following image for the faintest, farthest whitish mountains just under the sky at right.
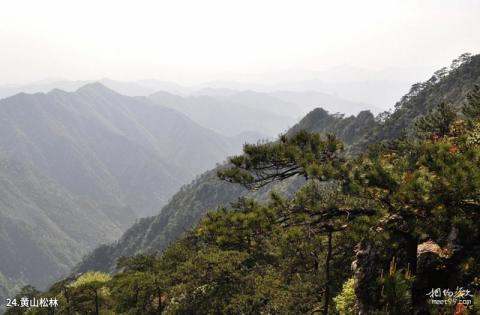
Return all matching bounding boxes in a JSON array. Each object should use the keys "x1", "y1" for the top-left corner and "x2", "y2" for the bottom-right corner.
[{"x1": 194, "y1": 64, "x2": 436, "y2": 110}]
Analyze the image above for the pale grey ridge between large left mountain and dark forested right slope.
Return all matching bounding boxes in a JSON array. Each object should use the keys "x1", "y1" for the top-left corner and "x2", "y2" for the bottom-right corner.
[{"x1": 148, "y1": 89, "x2": 378, "y2": 139}]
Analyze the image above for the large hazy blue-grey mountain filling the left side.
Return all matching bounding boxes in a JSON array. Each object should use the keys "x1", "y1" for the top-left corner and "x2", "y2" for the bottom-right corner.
[{"x1": 0, "y1": 83, "x2": 257, "y2": 298}]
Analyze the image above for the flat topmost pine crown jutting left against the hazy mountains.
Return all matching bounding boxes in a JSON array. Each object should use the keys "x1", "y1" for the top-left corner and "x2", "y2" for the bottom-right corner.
[{"x1": 218, "y1": 131, "x2": 343, "y2": 189}]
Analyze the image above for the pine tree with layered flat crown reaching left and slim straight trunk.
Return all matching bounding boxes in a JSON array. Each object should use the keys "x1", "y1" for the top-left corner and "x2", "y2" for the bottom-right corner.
[{"x1": 219, "y1": 131, "x2": 375, "y2": 315}]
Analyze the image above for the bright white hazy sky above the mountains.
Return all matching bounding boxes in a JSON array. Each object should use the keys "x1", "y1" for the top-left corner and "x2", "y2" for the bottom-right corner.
[{"x1": 0, "y1": 0, "x2": 480, "y2": 84}]
